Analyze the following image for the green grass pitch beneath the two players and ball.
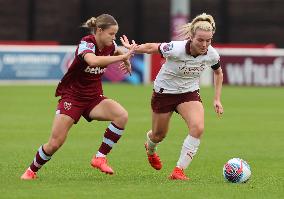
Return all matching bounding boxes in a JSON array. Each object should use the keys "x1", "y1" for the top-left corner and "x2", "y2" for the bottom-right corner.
[{"x1": 0, "y1": 84, "x2": 284, "y2": 199}]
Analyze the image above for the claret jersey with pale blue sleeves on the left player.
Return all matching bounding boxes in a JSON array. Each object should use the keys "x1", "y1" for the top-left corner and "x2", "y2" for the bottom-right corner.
[{"x1": 55, "y1": 35, "x2": 116, "y2": 99}]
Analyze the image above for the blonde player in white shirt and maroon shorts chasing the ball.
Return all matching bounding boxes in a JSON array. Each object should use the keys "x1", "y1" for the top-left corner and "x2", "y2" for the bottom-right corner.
[{"x1": 120, "y1": 13, "x2": 223, "y2": 180}]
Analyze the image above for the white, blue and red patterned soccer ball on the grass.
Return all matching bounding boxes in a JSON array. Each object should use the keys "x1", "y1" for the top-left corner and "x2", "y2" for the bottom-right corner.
[{"x1": 223, "y1": 158, "x2": 251, "y2": 183}]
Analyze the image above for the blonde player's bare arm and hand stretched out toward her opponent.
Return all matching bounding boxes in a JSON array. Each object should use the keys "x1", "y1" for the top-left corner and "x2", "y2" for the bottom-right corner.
[{"x1": 120, "y1": 35, "x2": 160, "y2": 54}]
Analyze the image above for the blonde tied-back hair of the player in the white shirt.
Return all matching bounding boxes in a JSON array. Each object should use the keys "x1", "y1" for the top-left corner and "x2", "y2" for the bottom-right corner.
[{"x1": 177, "y1": 13, "x2": 216, "y2": 39}]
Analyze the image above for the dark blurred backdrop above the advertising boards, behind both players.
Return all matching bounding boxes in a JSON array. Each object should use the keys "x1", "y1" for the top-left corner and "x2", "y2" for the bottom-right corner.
[{"x1": 0, "y1": 0, "x2": 284, "y2": 47}]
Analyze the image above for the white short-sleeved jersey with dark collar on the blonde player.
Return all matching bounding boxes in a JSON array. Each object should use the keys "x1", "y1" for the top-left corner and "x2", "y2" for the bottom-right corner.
[{"x1": 154, "y1": 40, "x2": 220, "y2": 94}]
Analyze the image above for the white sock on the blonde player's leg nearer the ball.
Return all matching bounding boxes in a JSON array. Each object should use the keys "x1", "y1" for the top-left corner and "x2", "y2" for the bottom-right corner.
[{"x1": 177, "y1": 135, "x2": 200, "y2": 169}]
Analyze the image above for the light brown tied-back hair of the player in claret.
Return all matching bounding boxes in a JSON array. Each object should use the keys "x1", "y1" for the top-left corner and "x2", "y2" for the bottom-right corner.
[{"x1": 82, "y1": 14, "x2": 118, "y2": 34}]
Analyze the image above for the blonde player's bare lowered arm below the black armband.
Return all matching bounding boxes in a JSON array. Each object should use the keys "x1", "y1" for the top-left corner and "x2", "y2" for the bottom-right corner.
[{"x1": 213, "y1": 67, "x2": 224, "y2": 116}]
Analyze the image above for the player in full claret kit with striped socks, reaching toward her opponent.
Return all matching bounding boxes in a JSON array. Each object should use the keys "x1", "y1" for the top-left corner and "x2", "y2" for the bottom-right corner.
[{"x1": 21, "y1": 14, "x2": 136, "y2": 180}]
